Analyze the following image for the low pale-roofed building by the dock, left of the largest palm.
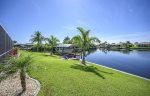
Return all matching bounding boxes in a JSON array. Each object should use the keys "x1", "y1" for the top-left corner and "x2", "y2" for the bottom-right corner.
[{"x1": 55, "y1": 44, "x2": 79, "y2": 54}]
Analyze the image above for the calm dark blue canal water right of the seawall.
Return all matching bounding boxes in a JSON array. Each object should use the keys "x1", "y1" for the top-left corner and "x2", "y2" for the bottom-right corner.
[{"x1": 86, "y1": 49, "x2": 150, "y2": 79}]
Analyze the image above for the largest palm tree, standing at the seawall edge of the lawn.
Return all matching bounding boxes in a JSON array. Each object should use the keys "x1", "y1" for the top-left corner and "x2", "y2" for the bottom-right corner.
[{"x1": 72, "y1": 27, "x2": 100, "y2": 65}]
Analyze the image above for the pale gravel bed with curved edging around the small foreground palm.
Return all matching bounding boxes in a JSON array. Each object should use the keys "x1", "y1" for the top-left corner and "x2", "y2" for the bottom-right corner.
[{"x1": 0, "y1": 73, "x2": 40, "y2": 96}]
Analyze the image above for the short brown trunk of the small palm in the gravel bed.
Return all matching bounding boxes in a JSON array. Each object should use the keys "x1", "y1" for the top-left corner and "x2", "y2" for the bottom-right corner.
[{"x1": 20, "y1": 69, "x2": 26, "y2": 92}]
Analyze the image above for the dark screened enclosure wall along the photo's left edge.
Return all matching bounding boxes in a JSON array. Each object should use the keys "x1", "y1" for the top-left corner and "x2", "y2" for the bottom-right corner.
[{"x1": 0, "y1": 25, "x2": 13, "y2": 58}]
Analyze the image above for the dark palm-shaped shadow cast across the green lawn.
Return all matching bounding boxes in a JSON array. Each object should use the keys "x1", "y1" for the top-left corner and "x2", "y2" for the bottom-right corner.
[{"x1": 71, "y1": 64, "x2": 113, "y2": 79}]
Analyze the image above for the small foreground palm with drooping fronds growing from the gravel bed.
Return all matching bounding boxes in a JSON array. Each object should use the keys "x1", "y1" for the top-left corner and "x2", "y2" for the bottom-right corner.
[{"x1": 0, "y1": 55, "x2": 32, "y2": 93}]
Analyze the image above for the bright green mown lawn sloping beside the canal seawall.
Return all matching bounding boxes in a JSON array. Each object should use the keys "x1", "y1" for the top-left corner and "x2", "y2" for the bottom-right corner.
[{"x1": 22, "y1": 51, "x2": 150, "y2": 96}]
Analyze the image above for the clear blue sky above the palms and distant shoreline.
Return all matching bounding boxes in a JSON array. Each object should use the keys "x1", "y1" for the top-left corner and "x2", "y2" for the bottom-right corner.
[{"x1": 0, "y1": 0, "x2": 150, "y2": 43}]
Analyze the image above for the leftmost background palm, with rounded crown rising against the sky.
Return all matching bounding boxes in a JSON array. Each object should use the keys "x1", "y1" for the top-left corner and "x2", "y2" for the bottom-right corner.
[{"x1": 30, "y1": 31, "x2": 44, "y2": 51}]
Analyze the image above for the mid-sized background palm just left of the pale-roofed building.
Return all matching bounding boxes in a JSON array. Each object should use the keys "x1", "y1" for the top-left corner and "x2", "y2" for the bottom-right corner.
[{"x1": 47, "y1": 35, "x2": 59, "y2": 55}]
